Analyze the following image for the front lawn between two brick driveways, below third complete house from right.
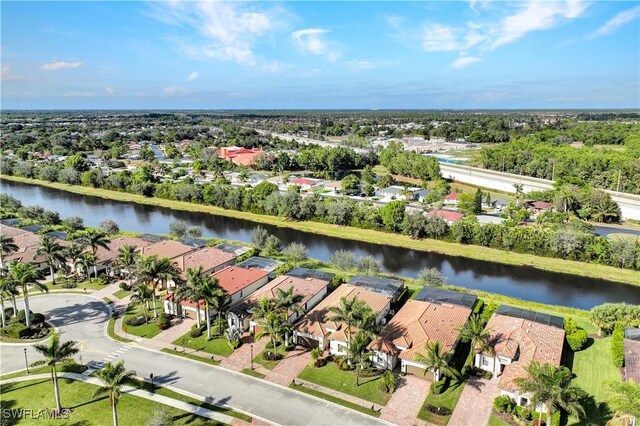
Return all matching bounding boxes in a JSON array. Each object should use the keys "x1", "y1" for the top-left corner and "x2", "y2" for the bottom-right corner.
[{"x1": 298, "y1": 362, "x2": 390, "y2": 405}]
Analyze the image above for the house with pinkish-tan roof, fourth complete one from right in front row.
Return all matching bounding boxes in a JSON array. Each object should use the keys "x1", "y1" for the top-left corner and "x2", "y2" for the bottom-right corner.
[{"x1": 227, "y1": 275, "x2": 331, "y2": 333}]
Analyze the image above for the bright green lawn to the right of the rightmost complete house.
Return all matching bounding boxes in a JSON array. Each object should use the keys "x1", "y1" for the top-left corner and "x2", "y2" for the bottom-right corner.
[{"x1": 569, "y1": 337, "x2": 622, "y2": 425}]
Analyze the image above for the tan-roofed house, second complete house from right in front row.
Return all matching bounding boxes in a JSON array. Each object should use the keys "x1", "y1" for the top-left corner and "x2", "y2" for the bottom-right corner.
[{"x1": 369, "y1": 287, "x2": 476, "y2": 381}]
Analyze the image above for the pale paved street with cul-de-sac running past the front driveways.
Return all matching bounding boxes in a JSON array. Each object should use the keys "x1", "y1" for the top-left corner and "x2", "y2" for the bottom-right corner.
[{"x1": 0, "y1": 294, "x2": 386, "y2": 425}]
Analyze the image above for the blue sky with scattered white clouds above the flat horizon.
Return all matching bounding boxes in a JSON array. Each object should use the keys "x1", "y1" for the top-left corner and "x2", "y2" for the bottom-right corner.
[{"x1": 0, "y1": 0, "x2": 640, "y2": 109}]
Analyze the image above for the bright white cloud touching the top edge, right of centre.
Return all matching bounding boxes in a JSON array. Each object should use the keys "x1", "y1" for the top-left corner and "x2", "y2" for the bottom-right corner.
[{"x1": 490, "y1": 0, "x2": 588, "y2": 49}]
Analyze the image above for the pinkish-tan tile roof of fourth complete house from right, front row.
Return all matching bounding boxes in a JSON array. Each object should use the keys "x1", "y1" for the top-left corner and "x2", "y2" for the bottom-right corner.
[{"x1": 232, "y1": 275, "x2": 329, "y2": 314}]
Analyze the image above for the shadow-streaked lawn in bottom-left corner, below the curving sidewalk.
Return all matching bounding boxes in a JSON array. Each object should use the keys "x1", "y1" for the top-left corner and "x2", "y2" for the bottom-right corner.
[{"x1": 0, "y1": 379, "x2": 220, "y2": 426}]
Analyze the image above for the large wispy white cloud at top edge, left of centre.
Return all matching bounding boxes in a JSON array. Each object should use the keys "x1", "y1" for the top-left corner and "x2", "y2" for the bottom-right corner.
[{"x1": 151, "y1": 1, "x2": 286, "y2": 66}]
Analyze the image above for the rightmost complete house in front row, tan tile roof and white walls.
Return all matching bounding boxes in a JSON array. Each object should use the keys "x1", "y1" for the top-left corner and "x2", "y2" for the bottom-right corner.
[{"x1": 474, "y1": 305, "x2": 565, "y2": 406}]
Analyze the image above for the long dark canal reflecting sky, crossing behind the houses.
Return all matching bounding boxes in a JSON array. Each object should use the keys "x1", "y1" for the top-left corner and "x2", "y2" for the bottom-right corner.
[{"x1": 0, "y1": 181, "x2": 640, "y2": 309}]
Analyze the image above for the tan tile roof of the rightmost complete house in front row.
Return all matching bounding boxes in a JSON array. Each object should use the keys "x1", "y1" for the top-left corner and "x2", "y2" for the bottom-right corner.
[{"x1": 487, "y1": 315, "x2": 564, "y2": 390}]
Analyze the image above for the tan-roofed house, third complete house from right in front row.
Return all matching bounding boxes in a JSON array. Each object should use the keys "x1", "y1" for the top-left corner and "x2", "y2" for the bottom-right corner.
[{"x1": 294, "y1": 284, "x2": 391, "y2": 355}]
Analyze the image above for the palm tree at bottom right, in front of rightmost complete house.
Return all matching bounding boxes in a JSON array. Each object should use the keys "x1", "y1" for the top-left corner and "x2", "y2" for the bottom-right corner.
[{"x1": 514, "y1": 361, "x2": 586, "y2": 425}]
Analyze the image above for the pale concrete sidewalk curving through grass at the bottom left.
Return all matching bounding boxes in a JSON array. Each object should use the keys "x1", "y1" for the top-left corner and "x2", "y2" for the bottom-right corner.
[{"x1": 0, "y1": 373, "x2": 234, "y2": 424}]
